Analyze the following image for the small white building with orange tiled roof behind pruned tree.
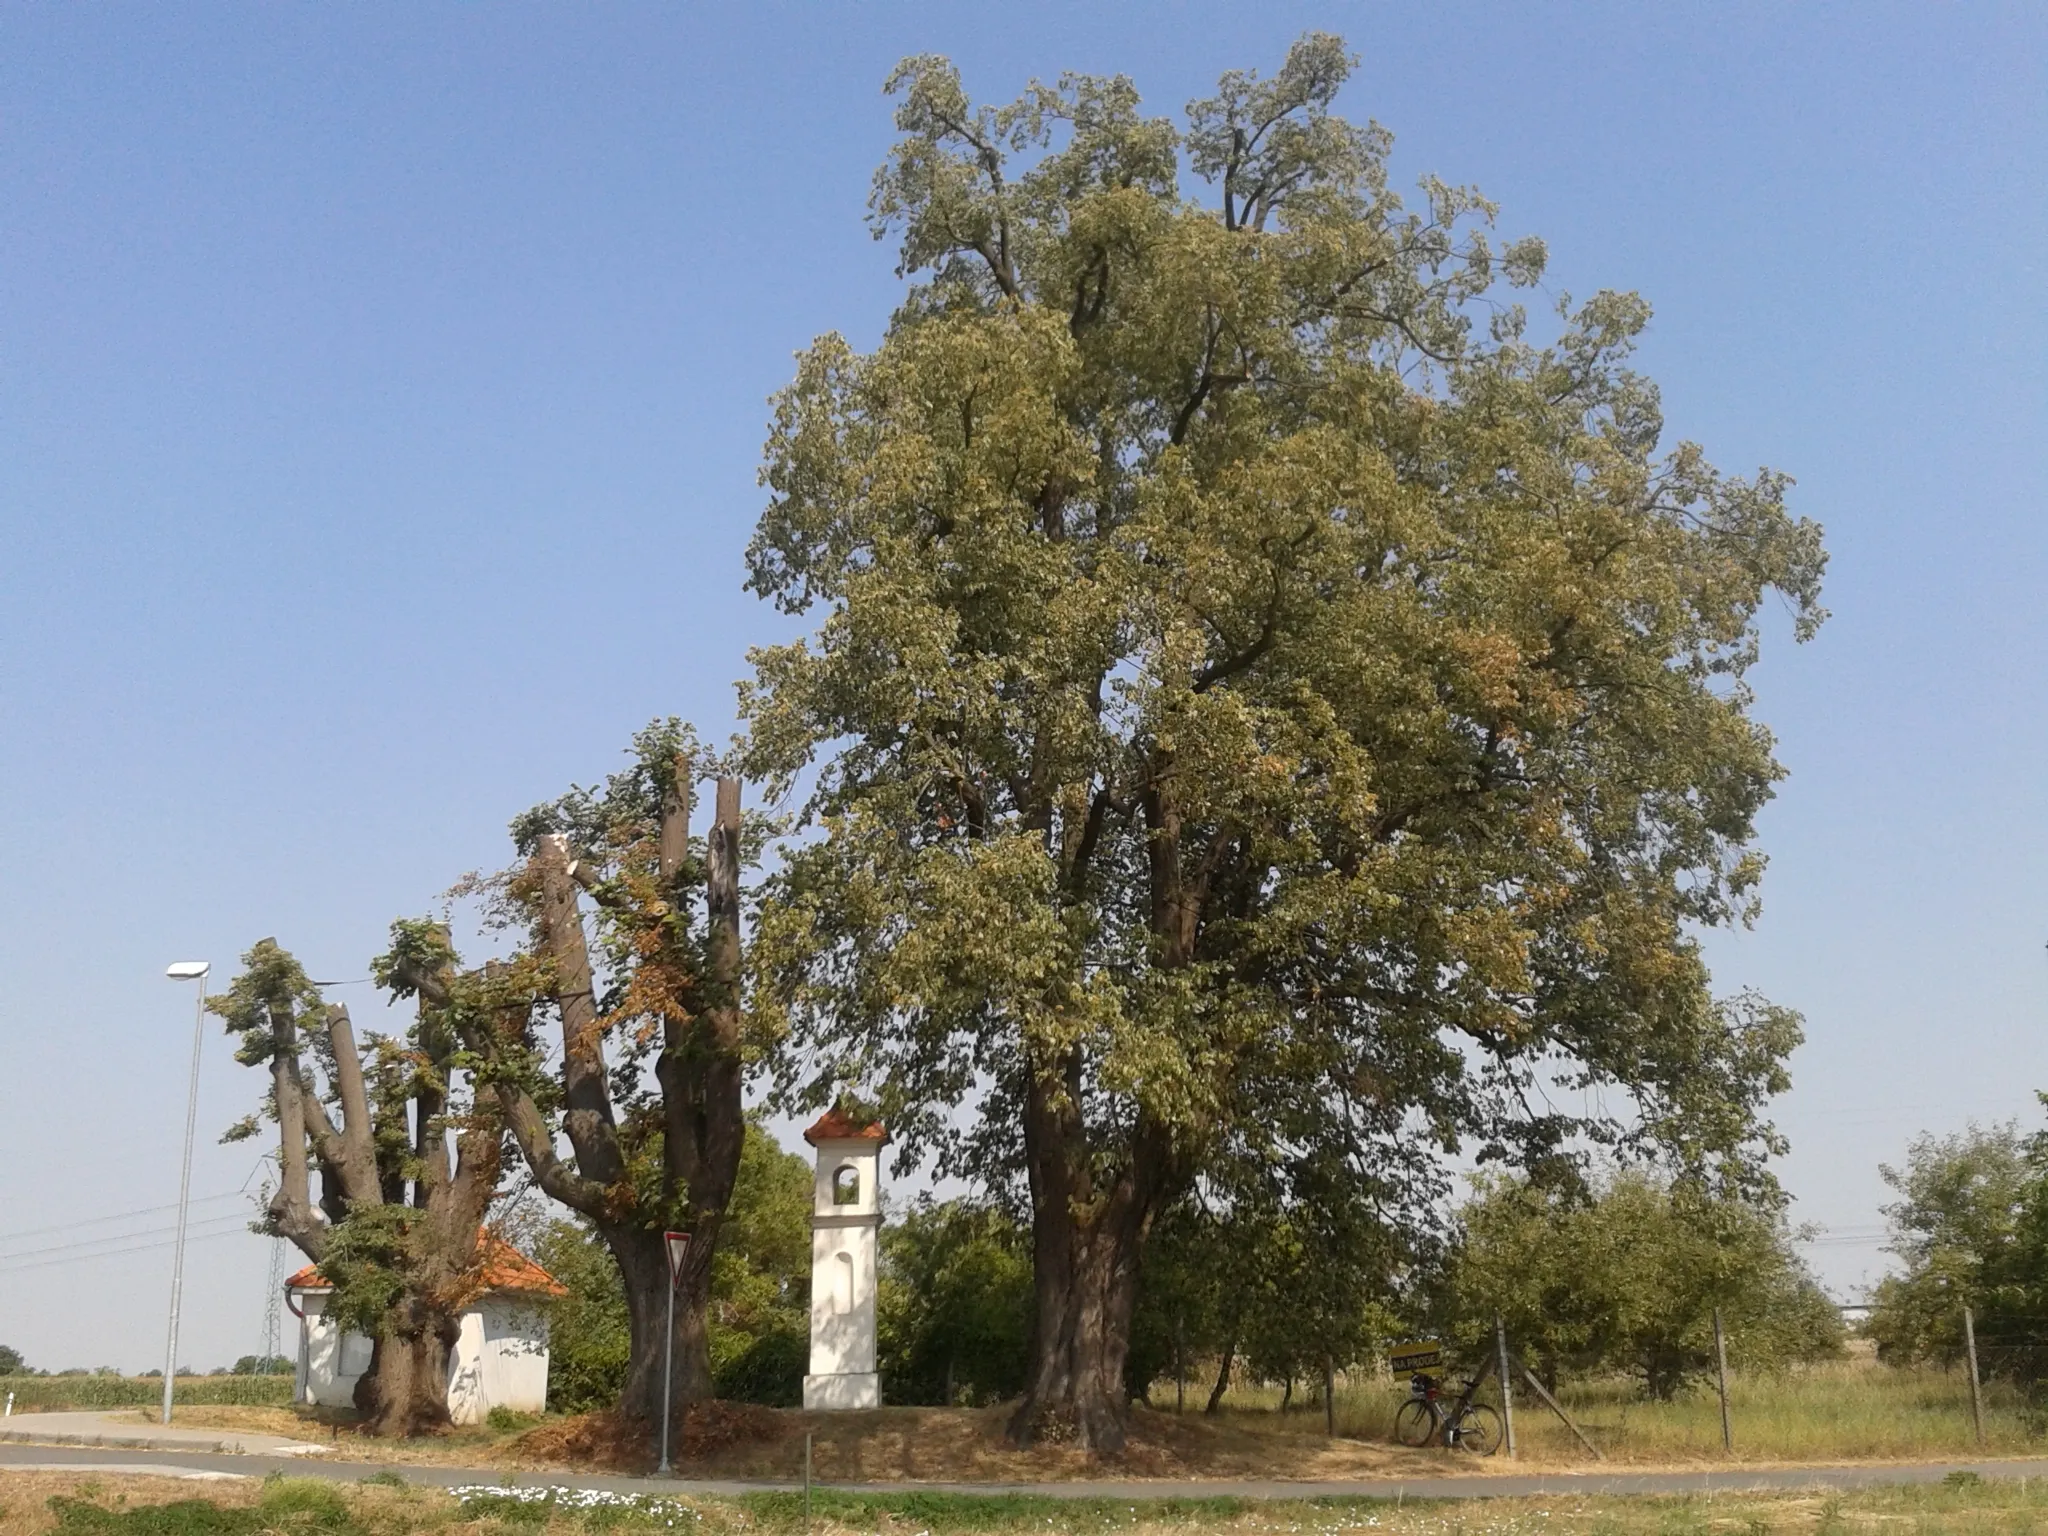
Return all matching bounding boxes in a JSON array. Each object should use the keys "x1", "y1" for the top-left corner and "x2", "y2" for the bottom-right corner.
[{"x1": 285, "y1": 1233, "x2": 567, "y2": 1423}]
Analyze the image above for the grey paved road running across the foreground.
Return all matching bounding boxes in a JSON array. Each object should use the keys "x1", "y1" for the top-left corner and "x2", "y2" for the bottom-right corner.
[{"x1": 12, "y1": 1444, "x2": 2048, "y2": 1499}]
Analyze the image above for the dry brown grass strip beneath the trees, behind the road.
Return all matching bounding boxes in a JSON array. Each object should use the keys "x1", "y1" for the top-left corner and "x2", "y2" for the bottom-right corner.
[{"x1": 83, "y1": 1362, "x2": 2048, "y2": 1483}]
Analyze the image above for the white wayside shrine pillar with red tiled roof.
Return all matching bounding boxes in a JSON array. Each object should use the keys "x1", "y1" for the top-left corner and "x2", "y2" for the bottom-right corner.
[{"x1": 803, "y1": 1110, "x2": 889, "y2": 1411}]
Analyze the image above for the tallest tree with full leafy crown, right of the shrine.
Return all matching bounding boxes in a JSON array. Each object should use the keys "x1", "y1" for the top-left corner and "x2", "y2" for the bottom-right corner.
[{"x1": 743, "y1": 35, "x2": 1823, "y2": 1450}]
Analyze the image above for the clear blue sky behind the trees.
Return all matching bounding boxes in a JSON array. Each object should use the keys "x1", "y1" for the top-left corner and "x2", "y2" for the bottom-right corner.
[{"x1": 0, "y1": 2, "x2": 2048, "y2": 1368}]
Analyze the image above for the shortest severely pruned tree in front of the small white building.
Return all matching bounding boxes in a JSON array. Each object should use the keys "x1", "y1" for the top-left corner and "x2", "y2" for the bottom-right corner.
[{"x1": 207, "y1": 938, "x2": 502, "y2": 1436}]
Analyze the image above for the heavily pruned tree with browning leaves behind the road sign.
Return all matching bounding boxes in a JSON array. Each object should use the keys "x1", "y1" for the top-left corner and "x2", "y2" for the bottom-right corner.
[{"x1": 377, "y1": 721, "x2": 745, "y2": 1417}]
